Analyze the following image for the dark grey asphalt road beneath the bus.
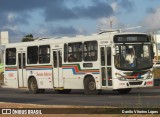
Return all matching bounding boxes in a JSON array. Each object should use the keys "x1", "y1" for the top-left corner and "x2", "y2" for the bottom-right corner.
[{"x1": 0, "y1": 88, "x2": 160, "y2": 108}]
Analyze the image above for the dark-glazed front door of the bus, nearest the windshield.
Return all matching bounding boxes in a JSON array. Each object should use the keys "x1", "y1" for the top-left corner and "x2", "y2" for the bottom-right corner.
[{"x1": 100, "y1": 46, "x2": 112, "y2": 87}]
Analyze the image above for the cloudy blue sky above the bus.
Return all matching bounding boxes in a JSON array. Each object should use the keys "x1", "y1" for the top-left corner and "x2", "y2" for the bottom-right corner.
[{"x1": 0, "y1": 0, "x2": 160, "y2": 42}]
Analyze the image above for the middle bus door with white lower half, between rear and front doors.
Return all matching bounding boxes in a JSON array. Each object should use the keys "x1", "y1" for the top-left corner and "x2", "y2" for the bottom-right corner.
[{"x1": 53, "y1": 49, "x2": 63, "y2": 88}]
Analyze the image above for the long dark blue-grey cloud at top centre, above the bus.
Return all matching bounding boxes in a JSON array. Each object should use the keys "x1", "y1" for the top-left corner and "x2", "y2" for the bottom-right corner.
[{"x1": 45, "y1": 1, "x2": 114, "y2": 21}]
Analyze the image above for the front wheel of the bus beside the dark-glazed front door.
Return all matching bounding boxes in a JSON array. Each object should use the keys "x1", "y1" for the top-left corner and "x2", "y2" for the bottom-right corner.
[{"x1": 84, "y1": 78, "x2": 101, "y2": 95}]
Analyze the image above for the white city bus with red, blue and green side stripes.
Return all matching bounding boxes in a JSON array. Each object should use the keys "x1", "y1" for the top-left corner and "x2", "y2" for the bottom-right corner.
[{"x1": 4, "y1": 32, "x2": 154, "y2": 94}]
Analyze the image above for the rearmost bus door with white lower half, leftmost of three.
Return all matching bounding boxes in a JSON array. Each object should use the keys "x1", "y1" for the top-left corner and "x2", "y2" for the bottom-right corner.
[{"x1": 18, "y1": 52, "x2": 27, "y2": 87}]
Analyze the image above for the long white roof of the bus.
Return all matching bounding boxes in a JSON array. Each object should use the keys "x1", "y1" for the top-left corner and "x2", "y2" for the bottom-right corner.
[{"x1": 6, "y1": 32, "x2": 146, "y2": 48}]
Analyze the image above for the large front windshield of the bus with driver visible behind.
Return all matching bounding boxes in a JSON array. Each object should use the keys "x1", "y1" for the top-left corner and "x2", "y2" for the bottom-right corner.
[{"x1": 115, "y1": 44, "x2": 153, "y2": 70}]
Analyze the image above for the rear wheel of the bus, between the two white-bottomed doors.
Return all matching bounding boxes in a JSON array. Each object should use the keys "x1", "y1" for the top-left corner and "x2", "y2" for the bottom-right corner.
[{"x1": 28, "y1": 78, "x2": 40, "y2": 94}]
